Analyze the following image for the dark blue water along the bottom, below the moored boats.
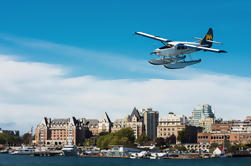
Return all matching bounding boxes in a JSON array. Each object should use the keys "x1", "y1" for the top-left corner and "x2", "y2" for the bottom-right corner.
[{"x1": 0, "y1": 154, "x2": 251, "y2": 166}]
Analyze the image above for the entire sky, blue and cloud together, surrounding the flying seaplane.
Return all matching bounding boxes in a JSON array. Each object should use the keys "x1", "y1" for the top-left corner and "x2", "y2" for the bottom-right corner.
[{"x1": 0, "y1": 0, "x2": 251, "y2": 132}]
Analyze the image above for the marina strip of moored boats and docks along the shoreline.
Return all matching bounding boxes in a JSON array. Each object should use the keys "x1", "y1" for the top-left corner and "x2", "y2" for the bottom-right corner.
[{"x1": 0, "y1": 145, "x2": 251, "y2": 159}]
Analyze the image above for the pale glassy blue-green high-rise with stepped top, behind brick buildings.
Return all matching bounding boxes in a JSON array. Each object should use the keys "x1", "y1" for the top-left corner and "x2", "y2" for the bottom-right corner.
[{"x1": 192, "y1": 104, "x2": 215, "y2": 126}]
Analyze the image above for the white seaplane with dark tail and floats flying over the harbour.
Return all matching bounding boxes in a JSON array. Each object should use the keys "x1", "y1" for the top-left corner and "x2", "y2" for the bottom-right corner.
[{"x1": 135, "y1": 28, "x2": 227, "y2": 69}]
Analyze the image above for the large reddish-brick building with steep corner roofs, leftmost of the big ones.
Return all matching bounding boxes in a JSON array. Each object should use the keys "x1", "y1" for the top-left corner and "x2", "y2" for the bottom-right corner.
[{"x1": 35, "y1": 117, "x2": 88, "y2": 146}]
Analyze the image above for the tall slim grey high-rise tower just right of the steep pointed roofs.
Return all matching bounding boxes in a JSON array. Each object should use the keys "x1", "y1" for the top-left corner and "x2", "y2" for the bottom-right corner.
[{"x1": 142, "y1": 108, "x2": 159, "y2": 140}]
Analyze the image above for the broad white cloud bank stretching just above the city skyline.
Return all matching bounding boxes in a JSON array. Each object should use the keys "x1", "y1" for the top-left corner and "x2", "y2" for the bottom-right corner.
[{"x1": 0, "y1": 56, "x2": 251, "y2": 134}]
